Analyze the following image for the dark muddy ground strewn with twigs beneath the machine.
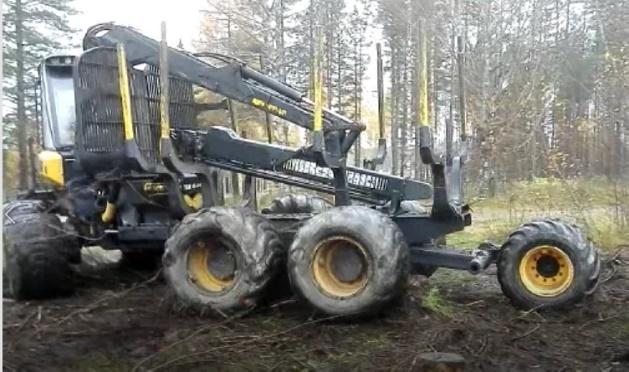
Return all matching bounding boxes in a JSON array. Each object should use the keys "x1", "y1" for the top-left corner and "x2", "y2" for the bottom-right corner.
[{"x1": 3, "y1": 250, "x2": 629, "y2": 371}]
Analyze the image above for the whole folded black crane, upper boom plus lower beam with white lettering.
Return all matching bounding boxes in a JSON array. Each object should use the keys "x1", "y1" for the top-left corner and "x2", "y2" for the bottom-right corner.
[{"x1": 77, "y1": 24, "x2": 432, "y2": 206}]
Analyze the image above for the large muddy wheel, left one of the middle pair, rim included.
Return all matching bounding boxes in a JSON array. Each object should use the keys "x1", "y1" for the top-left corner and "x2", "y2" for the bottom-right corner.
[{"x1": 162, "y1": 208, "x2": 282, "y2": 312}]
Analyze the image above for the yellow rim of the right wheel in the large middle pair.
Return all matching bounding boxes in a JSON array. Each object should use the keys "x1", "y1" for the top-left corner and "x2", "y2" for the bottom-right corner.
[{"x1": 311, "y1": 236, "x2": 369, "y2": 298}]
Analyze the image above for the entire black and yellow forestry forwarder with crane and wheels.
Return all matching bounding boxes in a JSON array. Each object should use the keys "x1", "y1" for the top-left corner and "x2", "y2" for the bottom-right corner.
[{"x1": 4, "y1": 24, "x2": 600, "y2": 315}]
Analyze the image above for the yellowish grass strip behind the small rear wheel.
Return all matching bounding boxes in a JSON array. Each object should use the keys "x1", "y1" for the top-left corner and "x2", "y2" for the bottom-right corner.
[{"x1": 448, "y1": 178, "x2": 629, "y2": 251}]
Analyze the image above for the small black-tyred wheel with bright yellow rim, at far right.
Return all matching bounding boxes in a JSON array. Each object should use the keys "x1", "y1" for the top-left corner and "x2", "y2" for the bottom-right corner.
[{"x1": 498, "y1": 220, "x2": 600, "y2": 309}]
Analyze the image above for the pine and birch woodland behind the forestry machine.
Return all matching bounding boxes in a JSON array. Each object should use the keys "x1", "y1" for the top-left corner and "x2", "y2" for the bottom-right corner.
[{"x1": 3, "y1": 0, "x2": 629, "y2": 235}]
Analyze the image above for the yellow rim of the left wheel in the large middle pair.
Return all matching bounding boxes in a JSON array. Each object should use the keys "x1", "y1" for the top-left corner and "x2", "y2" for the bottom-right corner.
[{"x1": 188, "y1": 240, "x2": 237, "y2": 293}]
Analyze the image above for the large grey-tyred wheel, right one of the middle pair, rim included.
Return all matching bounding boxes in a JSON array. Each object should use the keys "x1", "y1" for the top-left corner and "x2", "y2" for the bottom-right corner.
[{"x1": 288, "y1": 206, "x2": 410, "y2": 315}]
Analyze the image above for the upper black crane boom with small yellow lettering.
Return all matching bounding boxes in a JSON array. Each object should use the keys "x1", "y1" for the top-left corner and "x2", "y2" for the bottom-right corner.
[{"x1": 83, "y1": 23, "x2": 365, "y2": 137}]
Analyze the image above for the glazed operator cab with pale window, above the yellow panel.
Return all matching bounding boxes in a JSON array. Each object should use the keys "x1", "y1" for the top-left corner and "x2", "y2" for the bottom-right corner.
[{"x1": 39, "y1": 55, "x2": 76, "y2": 151}]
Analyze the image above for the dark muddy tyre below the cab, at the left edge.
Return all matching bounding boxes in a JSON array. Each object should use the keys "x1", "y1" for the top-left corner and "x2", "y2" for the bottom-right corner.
[{"x1": 3, "y1": 213, "x2": 75, "y2": 300}]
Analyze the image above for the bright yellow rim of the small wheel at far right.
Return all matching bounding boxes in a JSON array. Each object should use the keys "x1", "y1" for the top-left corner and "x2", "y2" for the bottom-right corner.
[{"x1": 519, "y1": 245, "x2": 574, "y2": 297}]
